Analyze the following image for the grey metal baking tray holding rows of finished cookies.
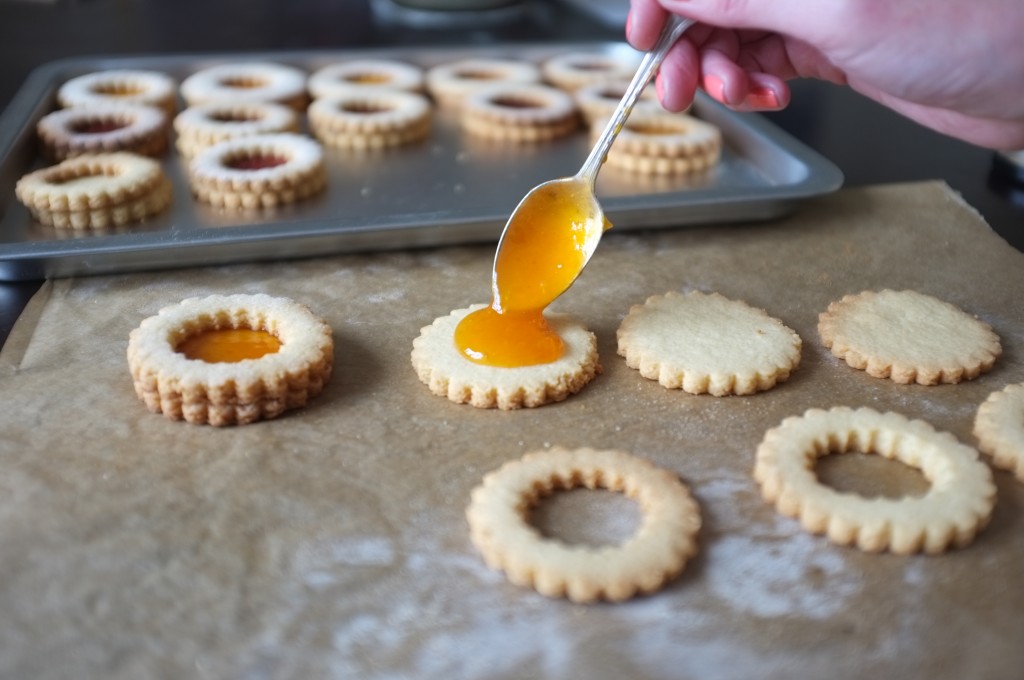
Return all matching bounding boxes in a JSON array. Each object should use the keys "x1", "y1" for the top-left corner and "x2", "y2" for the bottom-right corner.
[{"x1": 0, "y1": 43, "x2": 843, "y2": 281}]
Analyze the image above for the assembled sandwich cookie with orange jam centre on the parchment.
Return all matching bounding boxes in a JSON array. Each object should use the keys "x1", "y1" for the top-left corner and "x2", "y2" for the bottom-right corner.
[{"x1": 128, "y1": 295, "x2": 334, "y2": 426}]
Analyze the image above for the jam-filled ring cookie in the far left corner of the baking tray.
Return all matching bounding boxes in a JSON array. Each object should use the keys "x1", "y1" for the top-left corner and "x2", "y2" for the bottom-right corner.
[{"x1": 57, "y1": 69, "x2": 177, "y2": 116}]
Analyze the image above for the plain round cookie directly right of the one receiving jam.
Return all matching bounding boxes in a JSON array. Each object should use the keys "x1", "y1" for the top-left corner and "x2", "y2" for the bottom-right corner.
[{"x1": 616, "y1": 291, "x2": 803, "y2": 396}]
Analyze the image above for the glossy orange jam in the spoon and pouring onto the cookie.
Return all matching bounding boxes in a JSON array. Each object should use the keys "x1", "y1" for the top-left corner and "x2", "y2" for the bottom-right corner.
[{"x1": 455, "y1": 175, "x2": 610, "y2": 368}]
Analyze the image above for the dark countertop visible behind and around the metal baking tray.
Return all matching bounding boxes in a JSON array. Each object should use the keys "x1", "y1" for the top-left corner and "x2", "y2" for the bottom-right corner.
[{"x1": 0, "y1": 0, "x2": 1024, "y2": 340}]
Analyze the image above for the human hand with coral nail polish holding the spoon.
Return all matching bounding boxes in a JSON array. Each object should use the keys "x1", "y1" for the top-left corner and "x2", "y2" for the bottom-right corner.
[{"x1": 626, "y1": 0, "x2": 1024, "y2": 148}]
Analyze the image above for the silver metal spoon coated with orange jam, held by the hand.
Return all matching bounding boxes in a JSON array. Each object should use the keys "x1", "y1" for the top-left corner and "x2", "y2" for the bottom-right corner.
[{"x1": 492, "y1": 14, "x2": 694, "y2": 312}]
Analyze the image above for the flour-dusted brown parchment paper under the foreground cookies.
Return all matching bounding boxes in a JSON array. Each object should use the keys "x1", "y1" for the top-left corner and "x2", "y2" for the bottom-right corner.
[{"x1": 0, "y1": 183, "x2": 1024, "y2": 679}]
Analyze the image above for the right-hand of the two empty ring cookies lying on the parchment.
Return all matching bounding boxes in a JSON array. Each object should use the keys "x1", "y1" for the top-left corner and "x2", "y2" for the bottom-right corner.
[{"x1": 754, "y1": 408, "x2": 995, "y2": 554}]
